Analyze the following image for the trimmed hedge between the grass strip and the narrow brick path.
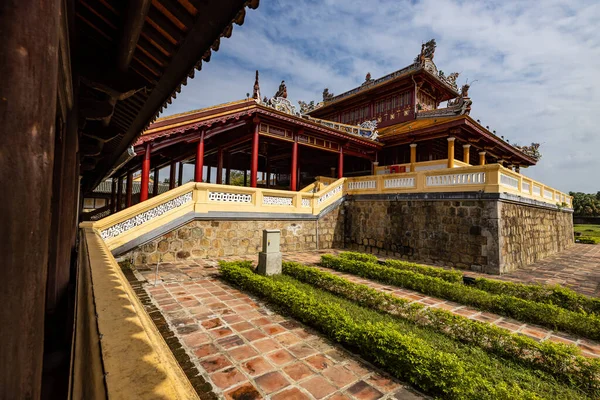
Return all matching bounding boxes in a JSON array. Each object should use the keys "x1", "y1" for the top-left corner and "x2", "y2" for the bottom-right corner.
[{"x1": 283, "y1": 262, "x2": 600, "y2": 398}]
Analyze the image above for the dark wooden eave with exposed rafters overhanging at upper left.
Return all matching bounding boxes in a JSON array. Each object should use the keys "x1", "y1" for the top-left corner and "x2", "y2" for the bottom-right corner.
[{"x1": 75, "y1": 0, "x2": 258, "y2": 191}]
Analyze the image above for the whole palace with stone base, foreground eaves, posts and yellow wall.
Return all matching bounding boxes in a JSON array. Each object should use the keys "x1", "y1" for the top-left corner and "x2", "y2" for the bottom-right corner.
[{"x1": 0, "y1": 0, "x2": 573, "y2": 399}]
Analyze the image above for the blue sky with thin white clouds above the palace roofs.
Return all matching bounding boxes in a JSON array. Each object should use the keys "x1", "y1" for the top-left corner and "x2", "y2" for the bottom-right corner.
[{"x1": 161, "y1": 0, "x2": 600, "y2": 193}]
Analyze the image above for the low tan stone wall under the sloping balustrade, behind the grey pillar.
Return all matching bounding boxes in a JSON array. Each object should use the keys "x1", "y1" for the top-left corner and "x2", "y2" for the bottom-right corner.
[{"x1": 125, "y1": 207, "x2": 344, "y2": 265}]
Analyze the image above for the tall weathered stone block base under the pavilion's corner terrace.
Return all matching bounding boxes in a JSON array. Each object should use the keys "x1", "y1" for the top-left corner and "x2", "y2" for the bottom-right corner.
[{"x1": 344, "y1": 196, "x2": 573, "y2": 274}]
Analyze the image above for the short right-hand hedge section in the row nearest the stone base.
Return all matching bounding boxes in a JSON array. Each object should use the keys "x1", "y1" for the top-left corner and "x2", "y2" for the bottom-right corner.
[{"x1": 474, "y1": 278, "x2": 600, "y2": 314}]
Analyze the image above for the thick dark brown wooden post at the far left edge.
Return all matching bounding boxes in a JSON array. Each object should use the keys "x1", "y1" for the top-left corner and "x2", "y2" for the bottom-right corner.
[{"x1": 0, "y1": 0, "x2": 61, "y2": 399}]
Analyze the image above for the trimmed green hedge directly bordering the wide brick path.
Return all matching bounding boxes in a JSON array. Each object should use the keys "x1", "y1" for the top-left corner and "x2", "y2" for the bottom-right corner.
[{"x1": 221, "y1": 263, "x2": 585, "y2": 399}]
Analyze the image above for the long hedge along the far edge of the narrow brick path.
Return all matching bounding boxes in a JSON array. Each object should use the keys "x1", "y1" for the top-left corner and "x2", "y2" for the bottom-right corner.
[{"x1": 321, "y1": 254, "x2": 600, "y2": 340}]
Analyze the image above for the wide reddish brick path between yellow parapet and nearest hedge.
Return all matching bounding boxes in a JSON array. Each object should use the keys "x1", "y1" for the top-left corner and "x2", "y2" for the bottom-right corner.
[{"x1": 138, "y1": 261, "x2": 424, "y2": 400}]
